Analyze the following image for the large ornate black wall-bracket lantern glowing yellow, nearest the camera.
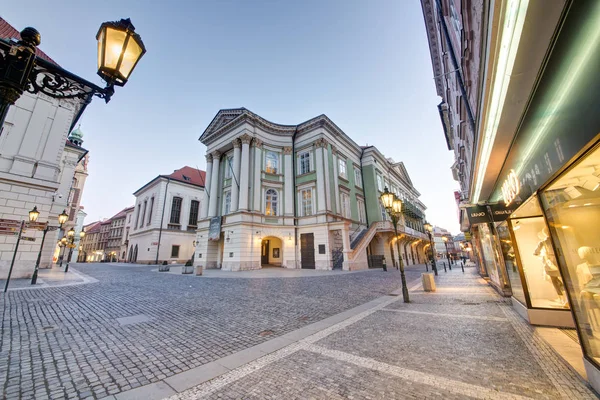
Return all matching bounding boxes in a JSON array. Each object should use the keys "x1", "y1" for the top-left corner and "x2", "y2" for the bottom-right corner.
[{"x1": 0, "y1": 18, "x2": 146, "y2": 127}]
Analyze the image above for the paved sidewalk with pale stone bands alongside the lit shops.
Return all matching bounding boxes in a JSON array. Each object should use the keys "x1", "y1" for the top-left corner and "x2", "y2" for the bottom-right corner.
[{"x1": 169, "y1": 268, "x2": 597, "y2": 400}]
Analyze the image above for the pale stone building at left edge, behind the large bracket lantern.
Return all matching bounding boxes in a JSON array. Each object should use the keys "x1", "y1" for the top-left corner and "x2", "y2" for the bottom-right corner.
[{"x1": 0, "y1": 18, "x2": 94, "y2": 278}]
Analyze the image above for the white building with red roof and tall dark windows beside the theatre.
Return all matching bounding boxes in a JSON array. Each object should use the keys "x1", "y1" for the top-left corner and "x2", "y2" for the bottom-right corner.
[{"x1": 127, "y1": 167, "x2": 205, "y2": 264}]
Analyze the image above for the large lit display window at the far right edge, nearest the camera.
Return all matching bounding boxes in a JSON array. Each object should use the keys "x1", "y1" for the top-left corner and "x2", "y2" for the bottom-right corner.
[{"x1": 541, "y1": 146, "x2": 600, "y2": 364}]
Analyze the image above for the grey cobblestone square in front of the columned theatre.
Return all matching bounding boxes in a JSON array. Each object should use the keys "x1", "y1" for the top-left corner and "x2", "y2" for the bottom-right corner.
[{"x1": 0, "y1": 264, "x2": 424, "y2": 399}]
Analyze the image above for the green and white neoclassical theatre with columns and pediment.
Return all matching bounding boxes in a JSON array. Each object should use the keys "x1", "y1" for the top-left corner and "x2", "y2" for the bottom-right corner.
[{"x1": 194, "y1": 108, "x2": 427, "y2": 271}]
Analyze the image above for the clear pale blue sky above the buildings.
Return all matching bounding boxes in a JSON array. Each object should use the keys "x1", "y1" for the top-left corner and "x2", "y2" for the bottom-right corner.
[{"x1": 0, "y1": 0, "x2": 458, "y2": 233}]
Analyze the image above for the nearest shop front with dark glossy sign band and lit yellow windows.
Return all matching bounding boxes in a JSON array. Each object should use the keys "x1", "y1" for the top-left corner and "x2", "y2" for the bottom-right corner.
[{"x1": 488, "y1": 1, "x2": 600, "y2": 390}]
